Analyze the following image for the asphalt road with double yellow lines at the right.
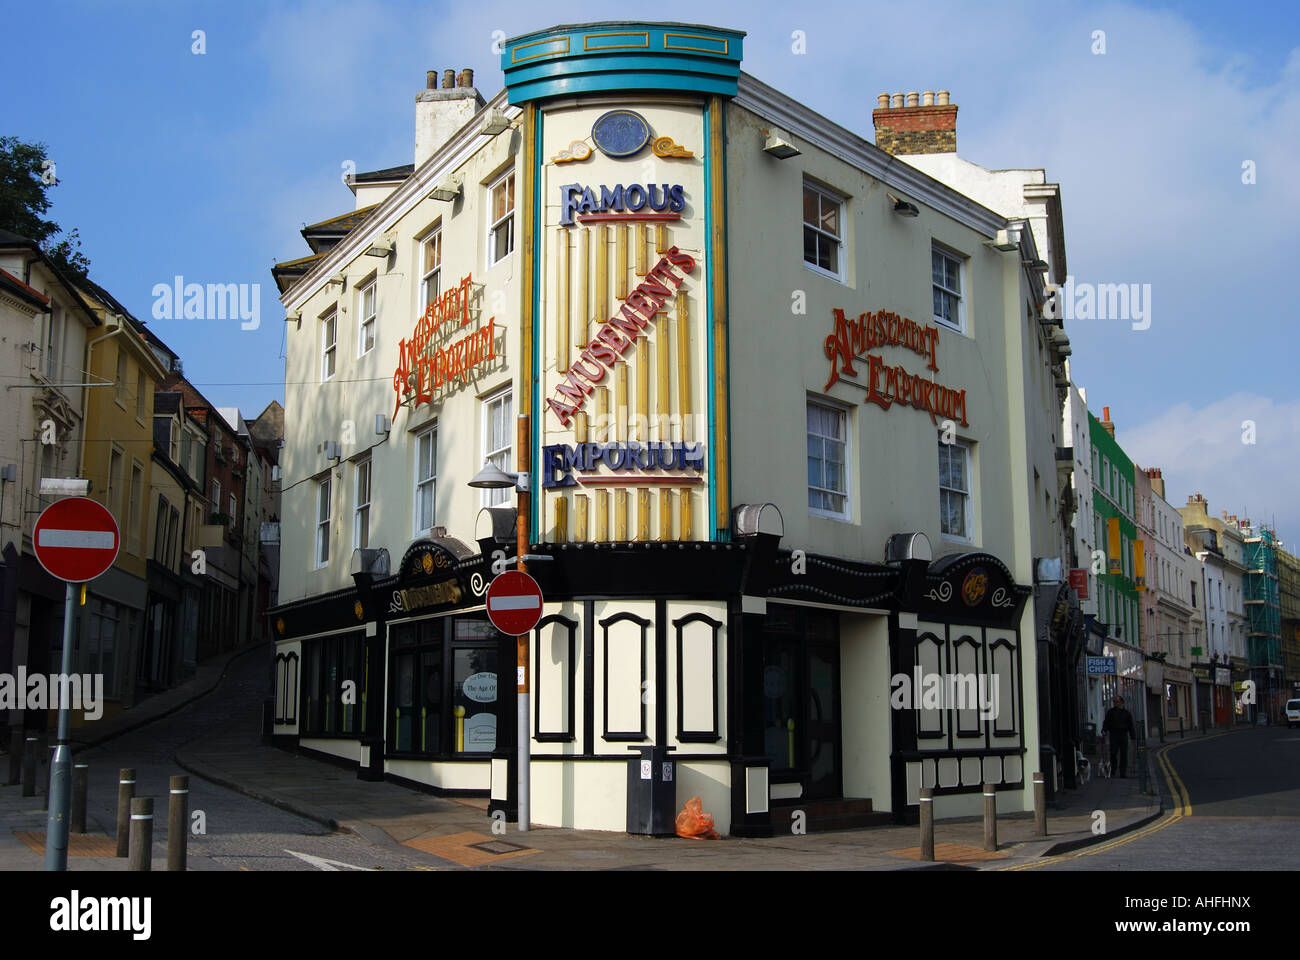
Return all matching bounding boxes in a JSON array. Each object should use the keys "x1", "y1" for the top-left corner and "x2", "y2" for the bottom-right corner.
[{"x1": 1035, "y1": 726, "x2": 1300, "y2": 870}]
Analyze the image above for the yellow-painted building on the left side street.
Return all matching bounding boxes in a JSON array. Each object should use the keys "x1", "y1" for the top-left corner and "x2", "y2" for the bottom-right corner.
[{"x1": 75, "y1": 281, "x2": 166, "y2": 715}]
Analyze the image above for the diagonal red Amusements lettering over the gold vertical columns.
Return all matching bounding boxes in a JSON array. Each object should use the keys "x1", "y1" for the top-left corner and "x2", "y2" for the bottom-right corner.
[{"x1": 546, "y1": 247, "x2": 696, "y2": 427}]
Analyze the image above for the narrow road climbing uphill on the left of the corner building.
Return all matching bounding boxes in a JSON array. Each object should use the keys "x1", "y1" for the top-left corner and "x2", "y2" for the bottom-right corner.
[{"x1": 77, "y1": 649, "x2": 436, "y2": 870}]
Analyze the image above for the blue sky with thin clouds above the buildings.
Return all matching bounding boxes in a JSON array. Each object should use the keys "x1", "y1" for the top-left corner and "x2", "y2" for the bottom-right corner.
[{"x1": 10, "y1": 0, "x2": 1300, "y2": 546}]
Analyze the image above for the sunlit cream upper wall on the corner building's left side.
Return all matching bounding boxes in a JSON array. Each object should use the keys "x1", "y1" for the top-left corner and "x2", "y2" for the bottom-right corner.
[{"x1": 280, "y1": 85, "x2": 520, "y2": 604}]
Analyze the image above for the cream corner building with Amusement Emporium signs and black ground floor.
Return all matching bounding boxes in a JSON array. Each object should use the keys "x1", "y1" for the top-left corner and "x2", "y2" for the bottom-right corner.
[{"x1": 270, "y1": 22, "x2": 1044, "y2": 835}]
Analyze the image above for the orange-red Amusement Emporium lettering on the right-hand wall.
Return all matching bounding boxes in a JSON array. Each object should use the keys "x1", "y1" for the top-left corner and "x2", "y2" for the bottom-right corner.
[{"x1": 826, "y1": 310, "x2": 970, "y2": 427}]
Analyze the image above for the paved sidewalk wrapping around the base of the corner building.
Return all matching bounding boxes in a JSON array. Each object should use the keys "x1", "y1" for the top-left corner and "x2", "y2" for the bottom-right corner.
[{"x1": 177, "y1": 718, "x2": 1180, "y2": 870}]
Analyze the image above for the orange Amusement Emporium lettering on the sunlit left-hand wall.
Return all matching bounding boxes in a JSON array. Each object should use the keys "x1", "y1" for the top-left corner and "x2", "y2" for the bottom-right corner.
[{"x1": 393, "y1": 274, "x2": 497, "y2": 419}]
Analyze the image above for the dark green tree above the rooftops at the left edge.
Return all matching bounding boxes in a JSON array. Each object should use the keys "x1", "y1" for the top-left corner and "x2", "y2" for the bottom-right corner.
[{"x1": 0, "y1": 137, "x2": 90, "y2": 278}]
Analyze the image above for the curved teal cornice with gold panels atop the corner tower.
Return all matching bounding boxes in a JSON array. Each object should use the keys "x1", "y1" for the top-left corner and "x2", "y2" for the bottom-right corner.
[{"x1": 501, "y1": 21, "x2": 745, "y2": 104}]
